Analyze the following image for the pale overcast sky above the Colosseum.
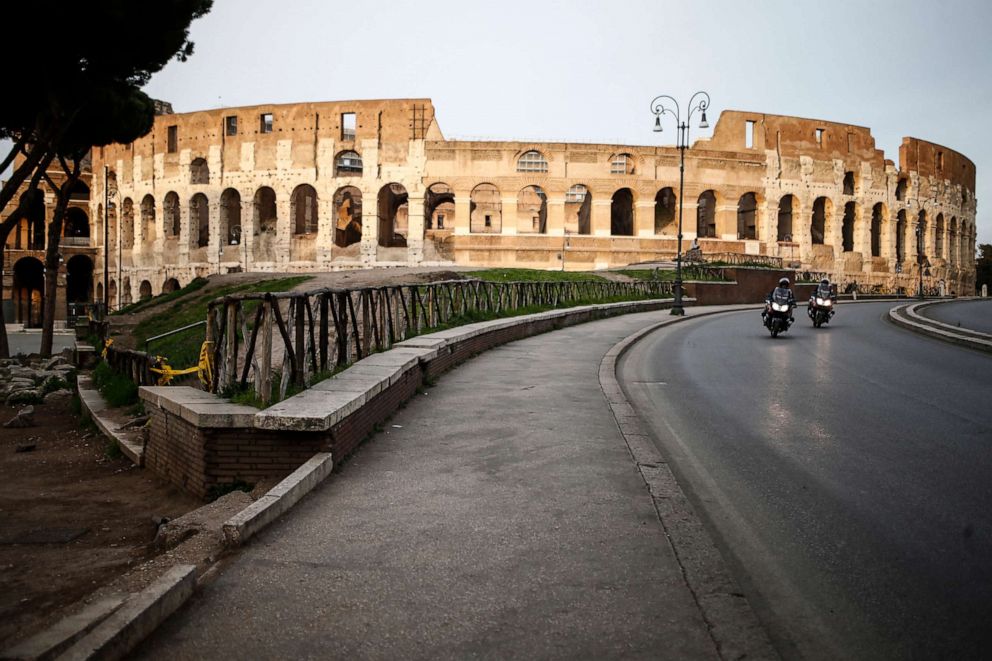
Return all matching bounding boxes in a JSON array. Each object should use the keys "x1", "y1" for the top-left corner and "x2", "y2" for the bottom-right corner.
[{"x1": 29, "y1": 0, "x2": 992, "y2": 243}]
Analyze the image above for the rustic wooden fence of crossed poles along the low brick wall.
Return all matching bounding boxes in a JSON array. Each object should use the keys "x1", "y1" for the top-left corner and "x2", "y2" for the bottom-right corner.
[{"x1": 206, "y1": 280, "x2": 672, "y2": 402}]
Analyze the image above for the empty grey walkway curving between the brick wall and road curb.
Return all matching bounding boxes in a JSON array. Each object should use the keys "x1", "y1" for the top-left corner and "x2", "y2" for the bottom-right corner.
[{"x1": 136, "y1": 311, "x2": 718, "y2": 659}]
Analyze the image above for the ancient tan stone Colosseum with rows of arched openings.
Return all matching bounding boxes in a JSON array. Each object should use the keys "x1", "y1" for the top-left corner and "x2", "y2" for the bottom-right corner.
[{"x1": 25, "y1": 99, "x2": 976, "y2": 314}]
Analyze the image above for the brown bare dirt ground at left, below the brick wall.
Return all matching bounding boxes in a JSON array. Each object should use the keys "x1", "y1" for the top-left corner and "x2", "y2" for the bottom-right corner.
[{"x1": 0, "y1": 399, "x2": 202, "y2": 649}]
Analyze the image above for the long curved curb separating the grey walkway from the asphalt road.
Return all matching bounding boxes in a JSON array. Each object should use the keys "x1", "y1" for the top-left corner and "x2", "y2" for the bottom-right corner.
[{"x1": 599, "y1": 304, "x2": 780, "y2": 659}]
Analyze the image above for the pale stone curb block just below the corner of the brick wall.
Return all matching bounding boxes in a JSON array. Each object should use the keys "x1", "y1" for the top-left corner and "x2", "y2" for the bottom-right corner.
[{"x1": 223, "y1": 452, "x2": 334, "y2": 547}]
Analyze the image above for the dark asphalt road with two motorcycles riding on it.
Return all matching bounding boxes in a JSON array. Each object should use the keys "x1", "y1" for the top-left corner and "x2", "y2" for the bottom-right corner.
[{"x1": 619, "y1": 303, "x2": 992, "y2": 659}]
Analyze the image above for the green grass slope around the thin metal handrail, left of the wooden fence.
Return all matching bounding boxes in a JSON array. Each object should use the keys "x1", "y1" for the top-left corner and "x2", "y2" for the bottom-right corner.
[{"x1": 134, "y1": 275, "x2": 312, "y2": 369}]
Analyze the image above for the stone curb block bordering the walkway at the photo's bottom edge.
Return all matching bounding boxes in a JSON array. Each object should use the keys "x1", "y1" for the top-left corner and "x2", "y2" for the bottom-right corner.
[{"x1": 58, "y1": 565, "x2": 196, "y2": 661}]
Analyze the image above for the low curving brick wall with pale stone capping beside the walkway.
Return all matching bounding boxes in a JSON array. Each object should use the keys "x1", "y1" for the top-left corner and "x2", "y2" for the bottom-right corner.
[{"x1": 140, "y1": 300, "x2": 671, "y2": 498}]
